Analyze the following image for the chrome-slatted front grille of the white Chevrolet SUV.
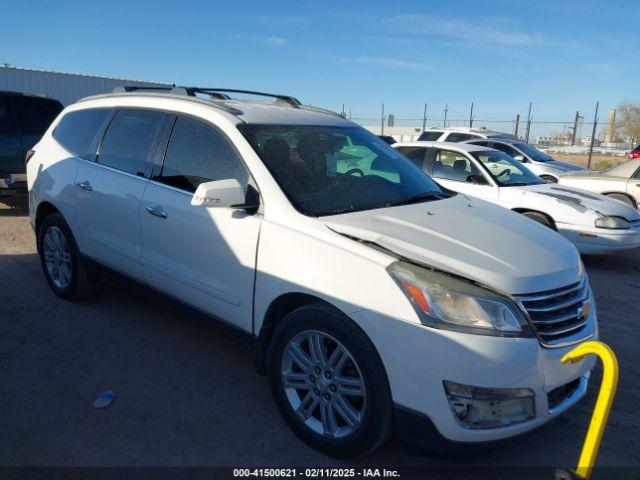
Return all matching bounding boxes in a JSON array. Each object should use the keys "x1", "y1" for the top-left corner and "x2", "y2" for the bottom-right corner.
[{"x1": 516, "y1": 277, "x2": 592, "y2": 347}]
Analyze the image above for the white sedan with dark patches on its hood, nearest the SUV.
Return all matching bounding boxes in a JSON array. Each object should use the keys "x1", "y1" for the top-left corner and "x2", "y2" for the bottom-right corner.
[{"x1": 393, "y1": 142, "x2": 640, "y2": 254}]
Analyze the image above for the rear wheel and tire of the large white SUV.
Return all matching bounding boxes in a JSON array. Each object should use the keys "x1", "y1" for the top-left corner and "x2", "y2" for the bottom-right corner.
[{"x1": 38, "y1": 213, "x2": 93, "y2": 300}]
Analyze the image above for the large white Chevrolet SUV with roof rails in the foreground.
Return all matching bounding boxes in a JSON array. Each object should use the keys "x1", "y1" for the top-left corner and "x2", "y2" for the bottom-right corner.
[{"x1": 27, "y1": 88, "x2": 597, "y2": 457}]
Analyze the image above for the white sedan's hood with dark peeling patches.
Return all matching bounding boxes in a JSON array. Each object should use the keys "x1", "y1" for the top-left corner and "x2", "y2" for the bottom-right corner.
[{"x1": 516, "y1": 183, "x2": 640, "y2": 221}]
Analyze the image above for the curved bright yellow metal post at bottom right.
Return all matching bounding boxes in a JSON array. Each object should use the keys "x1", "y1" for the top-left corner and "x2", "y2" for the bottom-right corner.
[{"x1": 562, "y1": 342, "x2": 618, "y2": 479}]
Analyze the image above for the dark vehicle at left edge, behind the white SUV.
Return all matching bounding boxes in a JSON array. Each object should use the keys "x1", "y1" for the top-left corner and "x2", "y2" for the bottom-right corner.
[{"x1": 0, "y1": 92, "x2": 62, "y2": 189}]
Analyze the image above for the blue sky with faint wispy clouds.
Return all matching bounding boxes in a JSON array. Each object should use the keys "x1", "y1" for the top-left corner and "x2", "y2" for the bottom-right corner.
[{"x1": 0, "y1": 0, "x2": 640, "y2": 127}]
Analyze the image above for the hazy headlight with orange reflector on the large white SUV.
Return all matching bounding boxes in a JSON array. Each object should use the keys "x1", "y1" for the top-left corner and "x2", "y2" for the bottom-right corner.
[{"x1": 387, "y1": 261, "x2": 533, "y2": 337}]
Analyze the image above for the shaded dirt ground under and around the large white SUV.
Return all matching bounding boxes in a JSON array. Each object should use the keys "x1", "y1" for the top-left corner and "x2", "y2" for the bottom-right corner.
[{"x1": 0, "y1": 191, "x2": 640, "y2": 472}]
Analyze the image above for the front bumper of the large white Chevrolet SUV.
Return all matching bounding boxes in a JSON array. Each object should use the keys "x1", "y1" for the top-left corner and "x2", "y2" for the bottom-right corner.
[{"x1": 352, "y1": 310, "x2": 596, "y2": 444}]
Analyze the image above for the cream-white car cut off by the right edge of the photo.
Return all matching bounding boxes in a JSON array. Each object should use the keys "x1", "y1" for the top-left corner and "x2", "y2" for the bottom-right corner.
[{"x1": 558, "y1": 158, "x2": 640, "y2": 208}]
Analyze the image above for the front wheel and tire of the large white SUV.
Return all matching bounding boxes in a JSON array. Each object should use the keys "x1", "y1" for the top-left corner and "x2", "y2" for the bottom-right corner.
[{"x1": 267, "y1": 303, "x2": 393, "y2": 458}]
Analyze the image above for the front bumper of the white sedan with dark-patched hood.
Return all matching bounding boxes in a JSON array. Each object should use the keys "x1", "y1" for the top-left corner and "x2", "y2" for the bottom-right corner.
[{"x1": 557, "y1": 223, "x2": 640, "y2": 255}]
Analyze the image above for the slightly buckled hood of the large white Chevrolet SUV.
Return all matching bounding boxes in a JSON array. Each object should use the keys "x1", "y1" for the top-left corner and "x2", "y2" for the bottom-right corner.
[{"x1": 321, "y1": 195, "x2": 579, "y2": 294}]
